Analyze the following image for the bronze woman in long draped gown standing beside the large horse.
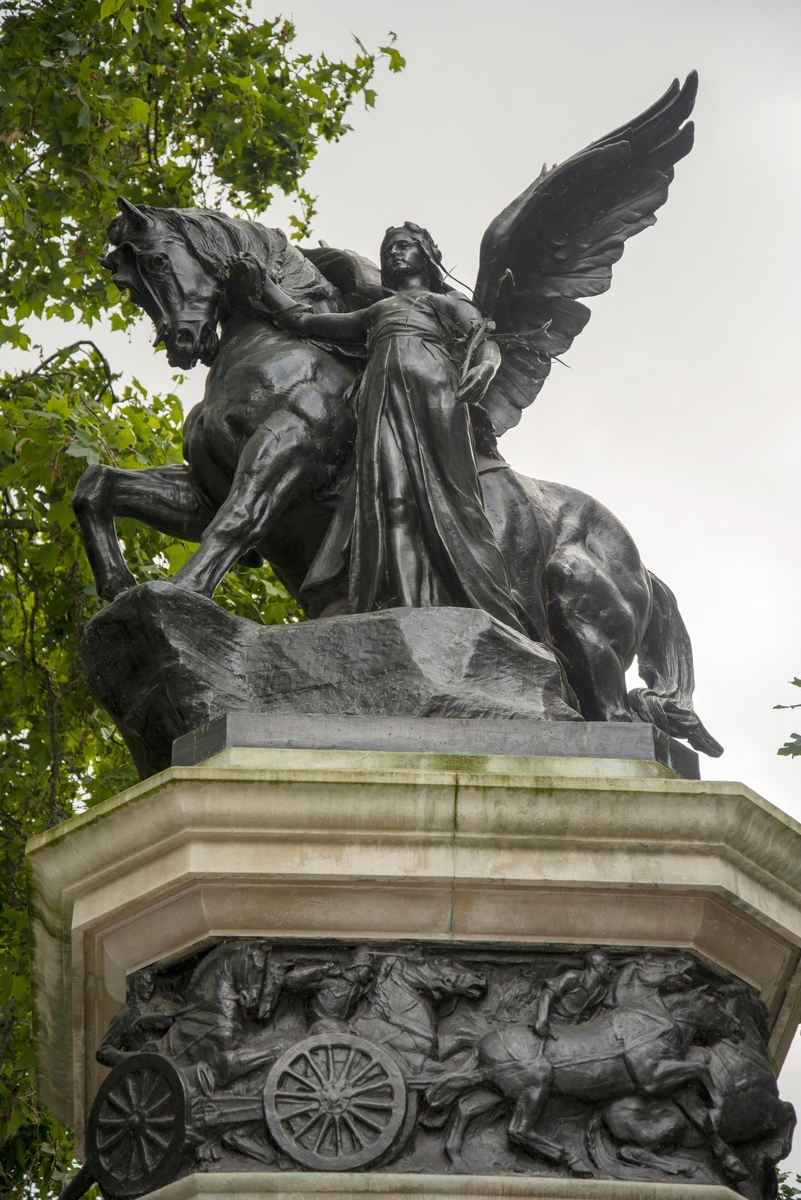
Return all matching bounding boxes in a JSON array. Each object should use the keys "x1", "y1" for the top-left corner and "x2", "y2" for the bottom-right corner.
[{"x1": 248, "y1": 222, "x2": 527, "y2": 636}]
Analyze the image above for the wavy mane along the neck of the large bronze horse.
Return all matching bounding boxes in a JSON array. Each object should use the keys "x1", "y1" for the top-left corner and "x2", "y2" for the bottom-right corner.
[{"x1": 108, "y1": 204, "x2": 342, "y2": 312}]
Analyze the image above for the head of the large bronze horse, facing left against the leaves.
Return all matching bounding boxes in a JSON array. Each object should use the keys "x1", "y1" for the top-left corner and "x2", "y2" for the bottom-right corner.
[{"x1": 101, "y1": 198, "x2": 222, "y2": 371}]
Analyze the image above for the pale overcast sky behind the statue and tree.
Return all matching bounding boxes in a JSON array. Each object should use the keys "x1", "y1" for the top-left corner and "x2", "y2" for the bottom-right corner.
[{"x1": 6, "y1": 0, "x2": 801, "y2": 1170}]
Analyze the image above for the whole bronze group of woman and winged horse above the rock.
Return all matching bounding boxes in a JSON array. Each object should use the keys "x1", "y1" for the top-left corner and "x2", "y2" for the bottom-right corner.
[{"x1": 76, "y1": 74, "x2": 721, "y2": 755}]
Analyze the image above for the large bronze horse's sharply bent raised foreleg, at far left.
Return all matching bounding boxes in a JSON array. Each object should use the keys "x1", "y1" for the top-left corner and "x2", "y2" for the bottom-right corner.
[{"x1": 72, "y1": 463, "x2": 215, "y2": 600}]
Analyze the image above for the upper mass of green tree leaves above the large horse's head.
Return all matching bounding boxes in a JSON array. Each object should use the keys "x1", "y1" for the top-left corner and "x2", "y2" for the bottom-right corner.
[{"x1": 0, "y1": 0, "x2": 403, "y2": 346}]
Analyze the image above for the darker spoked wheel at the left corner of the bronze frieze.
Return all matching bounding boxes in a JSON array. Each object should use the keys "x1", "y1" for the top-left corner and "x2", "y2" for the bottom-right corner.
[{"x1": 86, "y1": 1054, "x2": 186, "y2": 1198}]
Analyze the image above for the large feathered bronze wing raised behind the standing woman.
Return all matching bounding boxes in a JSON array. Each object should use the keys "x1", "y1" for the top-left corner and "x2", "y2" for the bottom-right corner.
[{"x1": 475, "y1": 71, "x2": 698, "y2": 452}]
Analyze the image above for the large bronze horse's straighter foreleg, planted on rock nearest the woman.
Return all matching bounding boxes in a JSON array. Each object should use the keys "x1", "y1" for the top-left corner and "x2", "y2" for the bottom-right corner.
[{"x1": 171, "y1": 410, "x2": 331, "y2": 596}]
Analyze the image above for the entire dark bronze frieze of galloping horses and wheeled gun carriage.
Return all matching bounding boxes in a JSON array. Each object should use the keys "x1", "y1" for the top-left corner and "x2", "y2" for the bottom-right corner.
[{"x1": 65, "y1": 940, "x2": 795, "y2": 1200}]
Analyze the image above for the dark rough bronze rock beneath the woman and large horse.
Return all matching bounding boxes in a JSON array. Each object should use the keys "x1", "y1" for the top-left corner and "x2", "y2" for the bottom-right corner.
[{"x1": 82, "y1": 583, "x2": 582, "y2": 779}]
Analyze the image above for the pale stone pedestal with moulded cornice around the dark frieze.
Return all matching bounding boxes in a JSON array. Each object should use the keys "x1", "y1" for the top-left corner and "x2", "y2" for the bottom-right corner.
[{"x1": 29, "y1": 746, "x2": 801, "y2": 1200}]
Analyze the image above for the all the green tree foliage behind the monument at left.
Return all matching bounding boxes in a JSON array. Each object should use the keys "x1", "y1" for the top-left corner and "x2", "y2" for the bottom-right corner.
[{"x1": 0, "y1": 0, "x2": 403, "y2": 1198}]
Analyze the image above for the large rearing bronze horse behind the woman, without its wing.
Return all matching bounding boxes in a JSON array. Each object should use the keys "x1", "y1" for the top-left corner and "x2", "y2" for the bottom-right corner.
[{"x1": 73, "y1": 200, "x2": 722, "y2": 756}]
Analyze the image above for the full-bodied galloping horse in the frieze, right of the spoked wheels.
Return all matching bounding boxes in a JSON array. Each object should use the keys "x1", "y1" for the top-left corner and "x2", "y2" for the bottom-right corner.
[{"x1": 428, "y1": 956, "x2": 747, "y2": 1178}]
